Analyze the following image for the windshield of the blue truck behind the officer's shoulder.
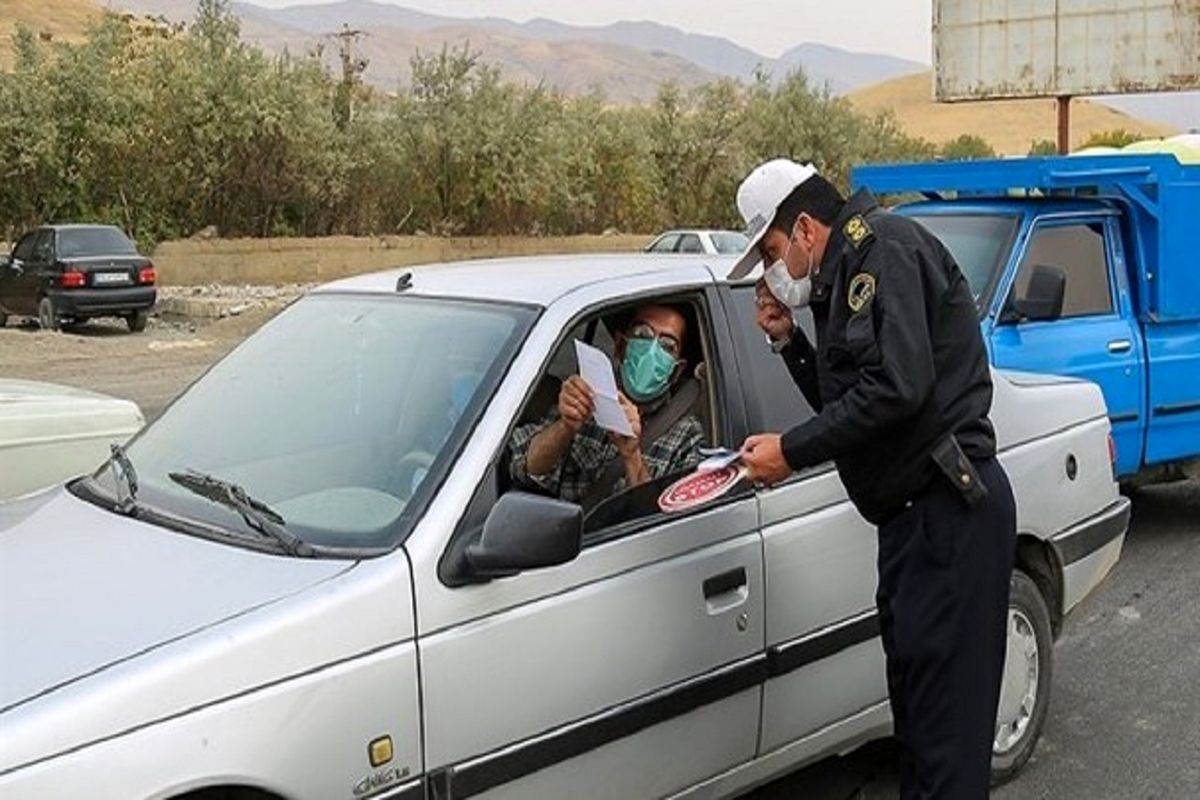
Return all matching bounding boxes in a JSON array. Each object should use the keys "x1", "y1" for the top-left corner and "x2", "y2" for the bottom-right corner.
[{"x1": 912, "y1": 213, "x2": 1019, "y2": 309}]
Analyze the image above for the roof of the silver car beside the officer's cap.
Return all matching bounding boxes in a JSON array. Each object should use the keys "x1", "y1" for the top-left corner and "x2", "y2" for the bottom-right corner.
[{"x1": 314, "y1": 252, "x2": 732, "y2": 306}]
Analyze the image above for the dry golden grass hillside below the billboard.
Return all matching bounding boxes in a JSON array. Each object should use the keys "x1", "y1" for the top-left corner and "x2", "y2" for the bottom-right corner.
[{"x1": 848, "y1": 72, "x2": 1178, "y2": 155}]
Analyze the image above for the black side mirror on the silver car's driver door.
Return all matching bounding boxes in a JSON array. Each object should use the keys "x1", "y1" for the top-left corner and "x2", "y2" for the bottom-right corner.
[{"x1": 463, "y1": 492, "x2": 583, "y2": 578}]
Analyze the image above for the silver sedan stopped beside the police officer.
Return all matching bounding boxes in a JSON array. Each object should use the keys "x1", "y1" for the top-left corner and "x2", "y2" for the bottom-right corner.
[{"x1": 0, "y1": 255, "x2": 1129, "y2": 800}]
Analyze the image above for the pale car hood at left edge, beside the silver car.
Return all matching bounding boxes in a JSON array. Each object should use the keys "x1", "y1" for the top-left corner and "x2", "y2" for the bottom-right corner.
[{"x1": 0, "y1": 380, "x2": 145, "y2": 501}]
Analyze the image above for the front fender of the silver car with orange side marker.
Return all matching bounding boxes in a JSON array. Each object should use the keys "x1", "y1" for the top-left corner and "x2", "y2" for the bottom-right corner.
[{"x1": 0, "y1": 640, "x2": 424, "y2": 800}]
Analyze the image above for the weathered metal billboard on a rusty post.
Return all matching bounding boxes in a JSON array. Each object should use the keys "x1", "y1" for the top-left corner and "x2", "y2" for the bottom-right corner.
[{"x1": 934, "y1": 0, "x2": 1200, "y2": 101}]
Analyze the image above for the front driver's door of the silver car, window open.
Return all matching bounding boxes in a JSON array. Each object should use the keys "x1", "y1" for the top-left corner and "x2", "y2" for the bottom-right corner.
[{"x1": 410, "y1": 291, "x2": 764, "y2": 799}]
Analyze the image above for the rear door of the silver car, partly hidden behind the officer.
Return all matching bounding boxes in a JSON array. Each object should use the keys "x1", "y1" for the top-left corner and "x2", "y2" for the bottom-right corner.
[{"x1": 725, "y1": 284, "x2": 890, "y2": 758}]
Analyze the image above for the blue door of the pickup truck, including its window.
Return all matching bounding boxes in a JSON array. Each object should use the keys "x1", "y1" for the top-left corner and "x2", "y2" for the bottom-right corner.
[{"x1": 990, "y1": 216, "x2": 1146, "y2": 475}]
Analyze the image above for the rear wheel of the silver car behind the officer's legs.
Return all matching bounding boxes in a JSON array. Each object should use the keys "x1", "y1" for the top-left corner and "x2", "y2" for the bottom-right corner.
[{"x1": 991, "y1": 569, "x2": 1054, "y2": 786}]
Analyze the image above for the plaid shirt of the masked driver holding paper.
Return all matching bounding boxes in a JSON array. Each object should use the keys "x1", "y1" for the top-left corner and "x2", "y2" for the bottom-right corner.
[{"x1": 509, "y1": 408, "x2": 704, "y2": 503}]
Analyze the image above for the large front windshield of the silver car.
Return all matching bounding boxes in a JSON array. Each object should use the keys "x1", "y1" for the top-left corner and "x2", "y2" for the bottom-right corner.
[{"x1": 82, "y1": 294, "x2": 535, "y2": 555}]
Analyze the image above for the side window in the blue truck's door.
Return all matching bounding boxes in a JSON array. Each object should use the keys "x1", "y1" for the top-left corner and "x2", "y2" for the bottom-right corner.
[{"x1": 1013, "y1": 222, "x2": 1112, "y2": 318}]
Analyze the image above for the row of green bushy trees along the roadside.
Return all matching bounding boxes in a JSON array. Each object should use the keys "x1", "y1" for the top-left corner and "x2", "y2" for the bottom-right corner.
[{"x1": 0, "y1": 0, "x2": 990, "y2": 245}]
